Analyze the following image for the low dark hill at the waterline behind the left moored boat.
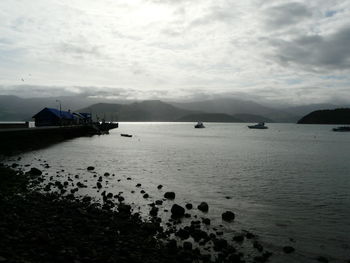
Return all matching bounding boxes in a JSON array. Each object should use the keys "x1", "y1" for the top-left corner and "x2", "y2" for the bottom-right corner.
[{"x1": 176, "y1": 113, "x2": 244, "y2": 122}]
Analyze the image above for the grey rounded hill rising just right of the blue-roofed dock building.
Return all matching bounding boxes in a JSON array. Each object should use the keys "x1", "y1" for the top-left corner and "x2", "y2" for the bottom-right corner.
[{"x1": 79, "y1": 100, "x2": 193, "y2": 121}]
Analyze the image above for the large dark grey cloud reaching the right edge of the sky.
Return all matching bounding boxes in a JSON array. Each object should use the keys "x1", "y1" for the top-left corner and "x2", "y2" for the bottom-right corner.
[{"x1": 270, "y1": 28, "x2": 350, "y2": 71}]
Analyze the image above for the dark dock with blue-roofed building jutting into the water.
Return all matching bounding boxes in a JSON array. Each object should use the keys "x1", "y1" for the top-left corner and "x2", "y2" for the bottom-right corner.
[{"x1": 0, "y1": 108, "x2": 118, "y2": 155}]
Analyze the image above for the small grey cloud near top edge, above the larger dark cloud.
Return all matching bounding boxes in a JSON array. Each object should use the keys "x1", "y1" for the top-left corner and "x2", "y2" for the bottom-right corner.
[{"x1": 265, "y1": 2, "x2": 312, "y2": 28}]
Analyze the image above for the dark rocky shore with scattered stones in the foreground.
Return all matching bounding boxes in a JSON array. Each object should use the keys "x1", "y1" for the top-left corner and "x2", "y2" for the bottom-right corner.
[{"x1": 0, "y1": 161, "x2": 284, "y2": 263}]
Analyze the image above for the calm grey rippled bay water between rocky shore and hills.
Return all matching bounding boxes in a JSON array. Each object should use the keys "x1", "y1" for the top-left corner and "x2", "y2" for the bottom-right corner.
[{"x1": 6, "y1": 123, "x2": 350, "y2": 262}]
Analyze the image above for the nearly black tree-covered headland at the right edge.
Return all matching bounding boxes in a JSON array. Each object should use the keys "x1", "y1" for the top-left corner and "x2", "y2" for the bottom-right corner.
[{"x1": 298, "y1": 108, "x2": 350, "y2": 124}]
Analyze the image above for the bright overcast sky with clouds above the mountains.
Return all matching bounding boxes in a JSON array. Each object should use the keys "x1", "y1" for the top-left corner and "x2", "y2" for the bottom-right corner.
[{"x1": 0, "y1": 0, "x2": 350, "y2": 104}]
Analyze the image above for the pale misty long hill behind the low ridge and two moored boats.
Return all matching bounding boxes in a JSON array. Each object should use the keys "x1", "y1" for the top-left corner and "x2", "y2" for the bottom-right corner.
[{"x1": 171, "y1": 98, "x2": 300, "y2": 123}]
